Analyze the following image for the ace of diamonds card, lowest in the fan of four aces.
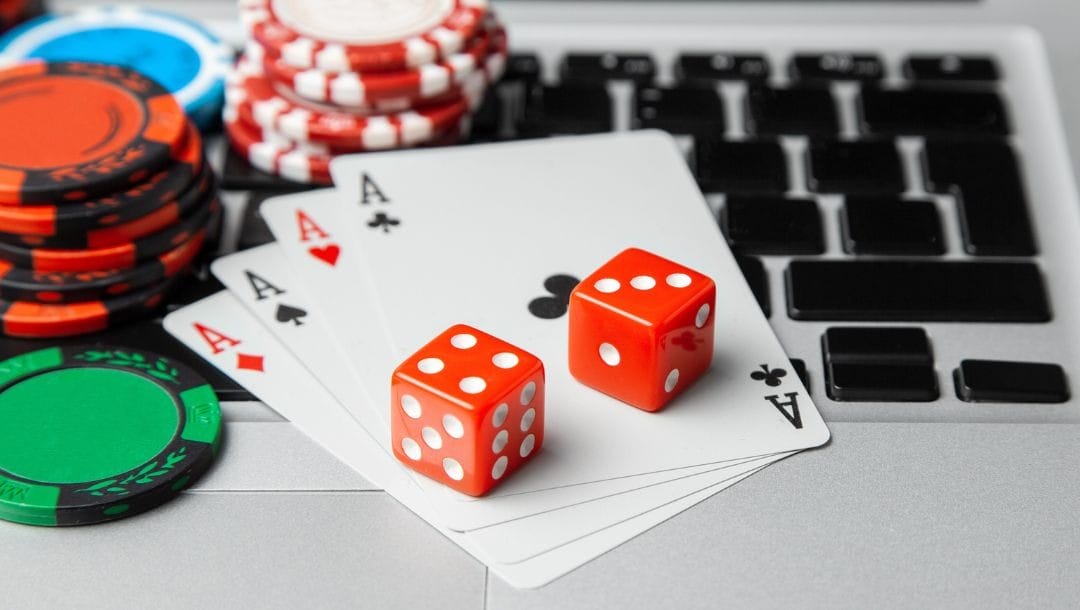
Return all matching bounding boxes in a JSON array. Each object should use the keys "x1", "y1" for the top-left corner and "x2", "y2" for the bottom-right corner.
[{"x1": 164, "y1": 291, "x2": 786, "y2": 587}]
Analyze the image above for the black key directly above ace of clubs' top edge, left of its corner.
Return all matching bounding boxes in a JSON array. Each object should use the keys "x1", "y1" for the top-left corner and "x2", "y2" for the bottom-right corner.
[{"x1": 518, "y1": 85, "x2": 615, "y2": 137}]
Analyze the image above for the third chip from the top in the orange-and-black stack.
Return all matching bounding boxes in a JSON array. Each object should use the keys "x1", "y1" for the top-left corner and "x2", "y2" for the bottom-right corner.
[{"x1": 0, "y1": 196, "x2": 221, "y2": 272}]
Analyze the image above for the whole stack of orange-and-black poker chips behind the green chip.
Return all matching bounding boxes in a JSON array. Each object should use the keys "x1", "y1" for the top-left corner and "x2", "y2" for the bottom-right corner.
[{"x1": 0, "y1": 62, "x2": 221, "y2": 337}]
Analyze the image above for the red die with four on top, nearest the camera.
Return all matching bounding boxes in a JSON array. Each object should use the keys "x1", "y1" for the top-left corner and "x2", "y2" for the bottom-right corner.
[{"x1": 390, "y1": 324, "x2": 544, "y2": 496}]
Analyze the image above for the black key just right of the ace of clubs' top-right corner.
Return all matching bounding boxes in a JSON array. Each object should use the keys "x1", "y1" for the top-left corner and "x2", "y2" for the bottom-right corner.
[{"x1": 694, "y1": 138, "x2": 789, "y2": 194}]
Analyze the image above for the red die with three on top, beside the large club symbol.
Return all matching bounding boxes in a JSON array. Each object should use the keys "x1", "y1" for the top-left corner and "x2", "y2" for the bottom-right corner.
[{"x1": 569, "y1": 248, "x2": 716, "y2": 411}]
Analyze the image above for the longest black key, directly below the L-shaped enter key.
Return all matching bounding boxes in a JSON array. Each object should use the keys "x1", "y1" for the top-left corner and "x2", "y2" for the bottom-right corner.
[{"x1": 786, "y1": 260, "x2": 1050, "y2": 322}]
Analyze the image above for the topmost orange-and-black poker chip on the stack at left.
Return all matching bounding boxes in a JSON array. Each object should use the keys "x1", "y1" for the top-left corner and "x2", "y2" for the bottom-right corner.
[{"x1": 0, "y1": 60, "x2": 188, "y2": 205}]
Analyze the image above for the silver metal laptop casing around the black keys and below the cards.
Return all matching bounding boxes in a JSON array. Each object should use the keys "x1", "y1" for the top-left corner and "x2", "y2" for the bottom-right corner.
[{"x1": 16, "y1": 0, "x2": 1080, "y2": 610}]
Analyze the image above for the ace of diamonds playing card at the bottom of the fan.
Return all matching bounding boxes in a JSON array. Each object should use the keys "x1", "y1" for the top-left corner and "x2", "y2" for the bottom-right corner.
[{"x1": 164, "y1": 292, "x2": 794, "y2": 586}]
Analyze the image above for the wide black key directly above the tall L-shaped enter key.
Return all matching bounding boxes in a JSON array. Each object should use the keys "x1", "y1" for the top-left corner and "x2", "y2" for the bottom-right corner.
[{"x1": 860, "y1": 89, "x2": 1010, "y2": 136}]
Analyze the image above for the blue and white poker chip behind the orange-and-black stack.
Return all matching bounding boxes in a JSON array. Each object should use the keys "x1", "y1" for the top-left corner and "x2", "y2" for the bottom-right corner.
[{"x1": 0, "y1": 5, "x2": 233, "y2": 128}]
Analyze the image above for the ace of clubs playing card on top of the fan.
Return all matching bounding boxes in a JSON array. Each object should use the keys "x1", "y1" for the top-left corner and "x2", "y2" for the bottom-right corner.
[{"x1": 324, "y1": 132, "x2": 828, "y2": 529}]
